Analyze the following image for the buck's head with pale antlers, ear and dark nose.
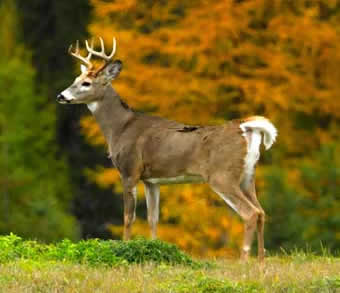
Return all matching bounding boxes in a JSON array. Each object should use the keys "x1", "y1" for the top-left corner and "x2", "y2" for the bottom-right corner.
[{"x1": 57, "y1": 38, "x2": 122, "y2": 104}]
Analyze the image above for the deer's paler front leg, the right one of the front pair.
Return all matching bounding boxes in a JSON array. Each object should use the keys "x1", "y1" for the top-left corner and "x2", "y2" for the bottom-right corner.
[{"x1": 144, "y1": 182, "x2": 159, "y2": 239}]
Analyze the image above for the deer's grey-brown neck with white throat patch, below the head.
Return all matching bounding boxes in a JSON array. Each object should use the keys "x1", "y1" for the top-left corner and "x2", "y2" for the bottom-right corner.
[{"x1": 87, "y1": 86, "x2": 135, "y2": 154}]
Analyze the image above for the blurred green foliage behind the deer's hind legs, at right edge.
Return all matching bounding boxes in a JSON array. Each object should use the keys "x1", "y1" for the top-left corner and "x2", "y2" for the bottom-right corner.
[{"x1": 263, "y1": 143, "x2": 340, "y2": 253}]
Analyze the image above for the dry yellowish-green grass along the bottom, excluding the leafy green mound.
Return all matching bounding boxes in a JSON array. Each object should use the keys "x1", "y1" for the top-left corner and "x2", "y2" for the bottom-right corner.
[{"x1": 0, "y1": 253, "x2": 340, "y2": 293}]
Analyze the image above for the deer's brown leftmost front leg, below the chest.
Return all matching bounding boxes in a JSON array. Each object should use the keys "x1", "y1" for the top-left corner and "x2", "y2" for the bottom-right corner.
[{"x1": 123, "y1": 185, "x2": 137, "y2": 240}]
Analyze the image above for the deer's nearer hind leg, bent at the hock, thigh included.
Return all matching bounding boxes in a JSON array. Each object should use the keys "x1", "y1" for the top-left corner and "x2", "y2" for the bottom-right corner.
[{"x1": 209, "y1": 174, "x2": 261, "y2": 260}]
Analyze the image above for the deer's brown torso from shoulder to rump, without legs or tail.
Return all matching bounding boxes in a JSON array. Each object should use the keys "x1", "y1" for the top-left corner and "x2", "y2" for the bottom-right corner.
[{"x1": 137, "y1": 117, "x2": 246, "y2": 178}]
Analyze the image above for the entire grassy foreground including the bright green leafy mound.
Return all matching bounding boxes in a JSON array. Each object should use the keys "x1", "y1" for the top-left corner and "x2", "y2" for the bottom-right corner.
[{"x1": 0, "y1": 235, "x2": 340, "y2": 293}]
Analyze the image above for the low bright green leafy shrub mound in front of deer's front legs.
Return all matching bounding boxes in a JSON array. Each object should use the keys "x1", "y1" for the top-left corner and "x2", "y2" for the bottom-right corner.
[{"x1": 0, "y1": 234, "x2": 200, "y2": 267}]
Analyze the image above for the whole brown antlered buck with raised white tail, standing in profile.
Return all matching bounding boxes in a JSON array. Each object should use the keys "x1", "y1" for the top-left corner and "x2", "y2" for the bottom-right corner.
[{"x1": 57, "y1": 38, "x2": 277, "y2": 262}]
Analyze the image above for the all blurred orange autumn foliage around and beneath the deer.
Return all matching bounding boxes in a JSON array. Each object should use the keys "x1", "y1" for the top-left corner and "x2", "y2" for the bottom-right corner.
[{"x1": 81, "y1": 0, "x2": 340, "y2": 256}]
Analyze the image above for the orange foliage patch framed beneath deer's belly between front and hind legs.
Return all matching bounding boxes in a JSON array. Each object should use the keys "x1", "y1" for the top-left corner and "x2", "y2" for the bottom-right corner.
[{"x1": 155, "y1": 185, "x2": 243, "y2": 256}]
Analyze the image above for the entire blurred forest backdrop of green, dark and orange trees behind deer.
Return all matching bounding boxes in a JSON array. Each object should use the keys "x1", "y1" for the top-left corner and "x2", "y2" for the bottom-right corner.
[{"x1": 0, "y1": 0, "x2": 340, "y2": 257}]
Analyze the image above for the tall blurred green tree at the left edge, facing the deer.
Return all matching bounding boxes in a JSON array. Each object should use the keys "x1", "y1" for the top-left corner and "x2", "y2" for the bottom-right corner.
[{"x1": 0, "y1": 0, "x2": 79, "y2": 241}]
